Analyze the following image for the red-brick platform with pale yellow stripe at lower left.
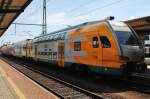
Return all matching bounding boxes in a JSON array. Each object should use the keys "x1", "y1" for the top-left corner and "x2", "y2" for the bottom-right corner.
[{"x1": 0, "y1": 59, "x2": 58, "y2": 99}]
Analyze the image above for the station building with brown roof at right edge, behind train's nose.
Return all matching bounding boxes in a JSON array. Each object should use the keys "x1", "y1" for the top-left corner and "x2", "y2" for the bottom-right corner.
[{"x1": 126, "y1": 16, "x2": 150, "y2": 57}]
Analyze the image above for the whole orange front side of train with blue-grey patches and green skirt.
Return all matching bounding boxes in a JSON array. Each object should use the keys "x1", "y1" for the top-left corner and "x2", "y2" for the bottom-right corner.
[{"x1": 65, "y1": 23, "x2": 122, "y2": 74}]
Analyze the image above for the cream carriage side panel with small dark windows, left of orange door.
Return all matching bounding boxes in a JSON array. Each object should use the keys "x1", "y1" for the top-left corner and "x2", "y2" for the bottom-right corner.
[{"x1": 35, "y1": 41, "x2": 58, "y2": 64}]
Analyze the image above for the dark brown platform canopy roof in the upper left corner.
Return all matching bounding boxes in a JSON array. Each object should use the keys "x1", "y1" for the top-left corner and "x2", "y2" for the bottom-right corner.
[{"x1": 0, "y1": 0, "x2": 32, "y2": 36}]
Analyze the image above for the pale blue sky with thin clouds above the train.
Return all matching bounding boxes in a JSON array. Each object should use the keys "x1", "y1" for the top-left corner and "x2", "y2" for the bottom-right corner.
[{"x1": 0, "y1": 0, "x2": 150, "y2": 45}]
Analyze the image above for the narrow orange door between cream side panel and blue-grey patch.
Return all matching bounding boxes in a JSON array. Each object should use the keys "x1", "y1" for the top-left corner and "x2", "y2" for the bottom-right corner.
[{"x1": 58, "y1": 42, "x2": 65, "y2": 67}]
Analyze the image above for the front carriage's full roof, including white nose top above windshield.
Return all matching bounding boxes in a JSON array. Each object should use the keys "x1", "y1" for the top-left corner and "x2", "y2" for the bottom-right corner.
[{"x1": 33, "y1": 16, "x2": 124, "y2": 43}]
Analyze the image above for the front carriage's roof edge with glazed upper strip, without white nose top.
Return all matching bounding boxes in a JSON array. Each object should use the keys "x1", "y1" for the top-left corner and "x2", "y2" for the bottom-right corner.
[{"x1": 33, "y1": 20, "x2": 107, "y2": 43}]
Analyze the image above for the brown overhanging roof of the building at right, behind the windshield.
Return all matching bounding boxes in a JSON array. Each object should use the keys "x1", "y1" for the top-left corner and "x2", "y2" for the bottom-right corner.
[{"x1": 126, "y1": 16, "x2": 150, "y2": 32}]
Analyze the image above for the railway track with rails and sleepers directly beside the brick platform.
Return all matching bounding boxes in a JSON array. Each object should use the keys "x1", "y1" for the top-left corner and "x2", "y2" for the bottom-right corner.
[{"x1": 1, "y1": 58, "x2": 105, "y2": 99}]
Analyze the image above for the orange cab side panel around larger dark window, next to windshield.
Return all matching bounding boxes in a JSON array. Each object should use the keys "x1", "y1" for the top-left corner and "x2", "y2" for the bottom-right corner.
[{"x1": 99, "y1": 25, "x2": 119, "y2": 68}]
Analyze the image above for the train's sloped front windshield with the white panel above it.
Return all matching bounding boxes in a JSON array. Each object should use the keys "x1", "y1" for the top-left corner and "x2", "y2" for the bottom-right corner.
[{"x1": 110, "y1": 21, "x2": 140, "y2": 46}]
